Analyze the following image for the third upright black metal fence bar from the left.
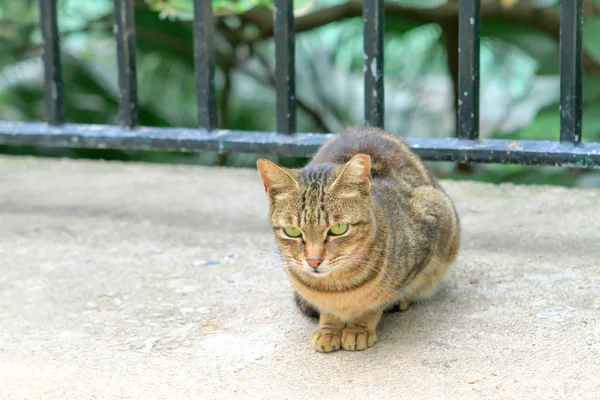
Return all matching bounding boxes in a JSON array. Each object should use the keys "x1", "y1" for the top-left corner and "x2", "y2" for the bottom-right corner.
[{"x1": 194, "y1": 0, "x2": 218, "y2": 130}]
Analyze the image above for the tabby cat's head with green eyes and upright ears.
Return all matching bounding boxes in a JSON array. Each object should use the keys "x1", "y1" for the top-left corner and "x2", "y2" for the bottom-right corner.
[{"x1": 257, "y1": 154, "x2": 375, "y2": 278}]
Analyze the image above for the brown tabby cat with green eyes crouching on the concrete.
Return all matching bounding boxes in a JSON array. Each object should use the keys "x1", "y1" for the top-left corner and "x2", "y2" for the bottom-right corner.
[{"x1": 257, "y1": 127, "x2": 460, "y2": 353}]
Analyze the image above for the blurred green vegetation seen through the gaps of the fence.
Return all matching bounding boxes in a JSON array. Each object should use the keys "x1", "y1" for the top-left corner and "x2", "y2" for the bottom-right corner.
[{"x1": 0, "y1": 0, "x2": 600, "y2": 187}]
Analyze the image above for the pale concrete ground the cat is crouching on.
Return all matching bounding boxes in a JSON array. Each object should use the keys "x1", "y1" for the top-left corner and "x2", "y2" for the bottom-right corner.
[{"x1": 0, "y1": 157, "x2": 600, "y2": 400}]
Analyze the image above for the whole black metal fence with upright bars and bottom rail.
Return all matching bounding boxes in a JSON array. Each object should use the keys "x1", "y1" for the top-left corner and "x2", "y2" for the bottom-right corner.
[{"x1": 0, "y1": 0, "x2": 600, "y2": 168}]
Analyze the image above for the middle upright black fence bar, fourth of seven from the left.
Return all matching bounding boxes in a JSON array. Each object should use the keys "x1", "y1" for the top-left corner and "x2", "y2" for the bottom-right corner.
[{"x1": 275, "y1": 0, "x2": 296, "y2": 135}]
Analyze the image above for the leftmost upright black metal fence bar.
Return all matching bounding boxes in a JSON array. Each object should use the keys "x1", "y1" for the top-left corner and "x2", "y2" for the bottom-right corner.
[{"x1": 40, "y1": 0, "x2": 65, "y2": 125}]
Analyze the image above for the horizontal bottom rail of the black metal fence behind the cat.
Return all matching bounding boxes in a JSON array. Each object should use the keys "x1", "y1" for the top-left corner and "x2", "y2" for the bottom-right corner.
[{"x1": 0, "y1": 121, "x2": 600, "y2": 168}]
